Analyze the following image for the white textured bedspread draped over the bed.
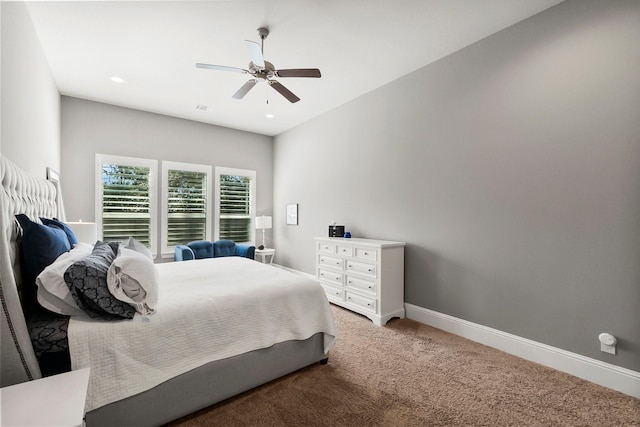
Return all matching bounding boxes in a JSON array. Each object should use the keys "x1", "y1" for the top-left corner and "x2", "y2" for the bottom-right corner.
[{"x1": 68, "y1": 257, "x2": 336, "y2": 411}]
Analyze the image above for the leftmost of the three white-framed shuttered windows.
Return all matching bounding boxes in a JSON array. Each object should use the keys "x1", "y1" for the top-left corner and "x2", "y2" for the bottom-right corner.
[{"x1": 96, "y1": 154, "x2": 158, "y2": 253}]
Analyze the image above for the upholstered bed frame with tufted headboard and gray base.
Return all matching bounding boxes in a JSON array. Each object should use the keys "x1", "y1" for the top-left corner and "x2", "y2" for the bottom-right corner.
[{"x1": 0, "y1": 155, "x2": 327, "y2": 427}]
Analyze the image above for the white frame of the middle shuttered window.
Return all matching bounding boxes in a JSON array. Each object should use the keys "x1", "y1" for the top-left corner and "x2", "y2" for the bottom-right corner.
[{"x1": 161, "y1": 160, "x2": 213, "y2": 258}]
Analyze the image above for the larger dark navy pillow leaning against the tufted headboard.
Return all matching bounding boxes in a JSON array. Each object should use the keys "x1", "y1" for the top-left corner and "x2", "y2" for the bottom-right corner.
[{"x1": 16, "y1": 214, "x2": 71, "y2": 307}]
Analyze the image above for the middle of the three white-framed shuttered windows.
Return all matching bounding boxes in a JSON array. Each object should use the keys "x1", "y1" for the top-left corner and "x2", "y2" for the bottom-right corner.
[{"x1": 162, "y1": 162, "x2": 212, "y2": 256}]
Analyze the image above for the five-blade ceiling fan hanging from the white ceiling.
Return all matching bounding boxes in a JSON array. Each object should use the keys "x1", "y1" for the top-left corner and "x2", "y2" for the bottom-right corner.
[{"x1": 196, "y1": 27, "x2": 321, "y2": 103}]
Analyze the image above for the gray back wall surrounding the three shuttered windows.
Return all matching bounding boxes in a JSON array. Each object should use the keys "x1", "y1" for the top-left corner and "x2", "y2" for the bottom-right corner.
[{"x1": 61, "y1": 96, "x2": 273, "y2": 253}]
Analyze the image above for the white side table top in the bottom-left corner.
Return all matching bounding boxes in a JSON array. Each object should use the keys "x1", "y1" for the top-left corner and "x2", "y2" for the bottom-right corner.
[{"x1": 0, "y1": 368, "x2": 89, "y2": 426}]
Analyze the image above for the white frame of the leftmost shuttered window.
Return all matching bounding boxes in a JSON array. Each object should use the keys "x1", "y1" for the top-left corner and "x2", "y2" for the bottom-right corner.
[{"x1": 94, "y1": 154, "x2": 158, "y2": 257}]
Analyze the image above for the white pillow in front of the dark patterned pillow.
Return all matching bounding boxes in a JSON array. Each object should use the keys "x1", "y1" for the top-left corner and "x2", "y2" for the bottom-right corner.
[{"x1": 107, "y1": 246, "x2": 158, "y2": 315}]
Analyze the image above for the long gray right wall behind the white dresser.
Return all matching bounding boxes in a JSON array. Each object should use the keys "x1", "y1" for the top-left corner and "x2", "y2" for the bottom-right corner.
[{"x1": 274, "y1": 0, "x2": 640, "y2": 371}]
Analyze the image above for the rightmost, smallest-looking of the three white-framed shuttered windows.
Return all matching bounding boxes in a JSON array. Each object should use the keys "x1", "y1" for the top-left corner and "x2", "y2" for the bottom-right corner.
[{"x1": 215, "y1": 167, "x2": 256, "y2": 243}]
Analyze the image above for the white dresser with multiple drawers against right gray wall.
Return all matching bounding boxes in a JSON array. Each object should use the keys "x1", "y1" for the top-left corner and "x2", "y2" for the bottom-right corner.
[{"x1": 315, "y1": 237, "x2": 405, "y2": 326}]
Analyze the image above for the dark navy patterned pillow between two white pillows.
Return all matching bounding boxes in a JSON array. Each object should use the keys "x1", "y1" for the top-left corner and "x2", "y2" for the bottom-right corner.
[{"x1": 64, "y1": 241, "x2": 136, "y2": 320}]
